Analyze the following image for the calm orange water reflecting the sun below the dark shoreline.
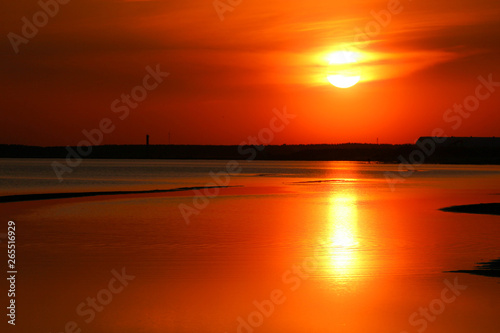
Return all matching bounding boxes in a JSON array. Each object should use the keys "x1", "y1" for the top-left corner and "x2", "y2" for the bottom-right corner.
[{"x1": 0, "y1": 159, "x2": 500, "y2": 333}]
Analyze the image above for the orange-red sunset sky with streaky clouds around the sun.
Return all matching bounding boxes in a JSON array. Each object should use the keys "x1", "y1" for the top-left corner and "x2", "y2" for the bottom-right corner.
[{"x1": 0, "y1": 0, "x2": 500, "y2": 146}]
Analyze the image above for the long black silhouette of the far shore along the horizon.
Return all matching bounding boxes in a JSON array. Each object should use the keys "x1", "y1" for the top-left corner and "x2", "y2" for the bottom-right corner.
[{"x1": 0, "y1": 137, "x2": 500, "y2": 164}]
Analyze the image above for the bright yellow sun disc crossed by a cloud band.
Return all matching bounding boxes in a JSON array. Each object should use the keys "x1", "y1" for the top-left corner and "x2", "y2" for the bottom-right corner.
[{"x1": 326, "y1": 51, "x2": 361, "y2": 88}]
